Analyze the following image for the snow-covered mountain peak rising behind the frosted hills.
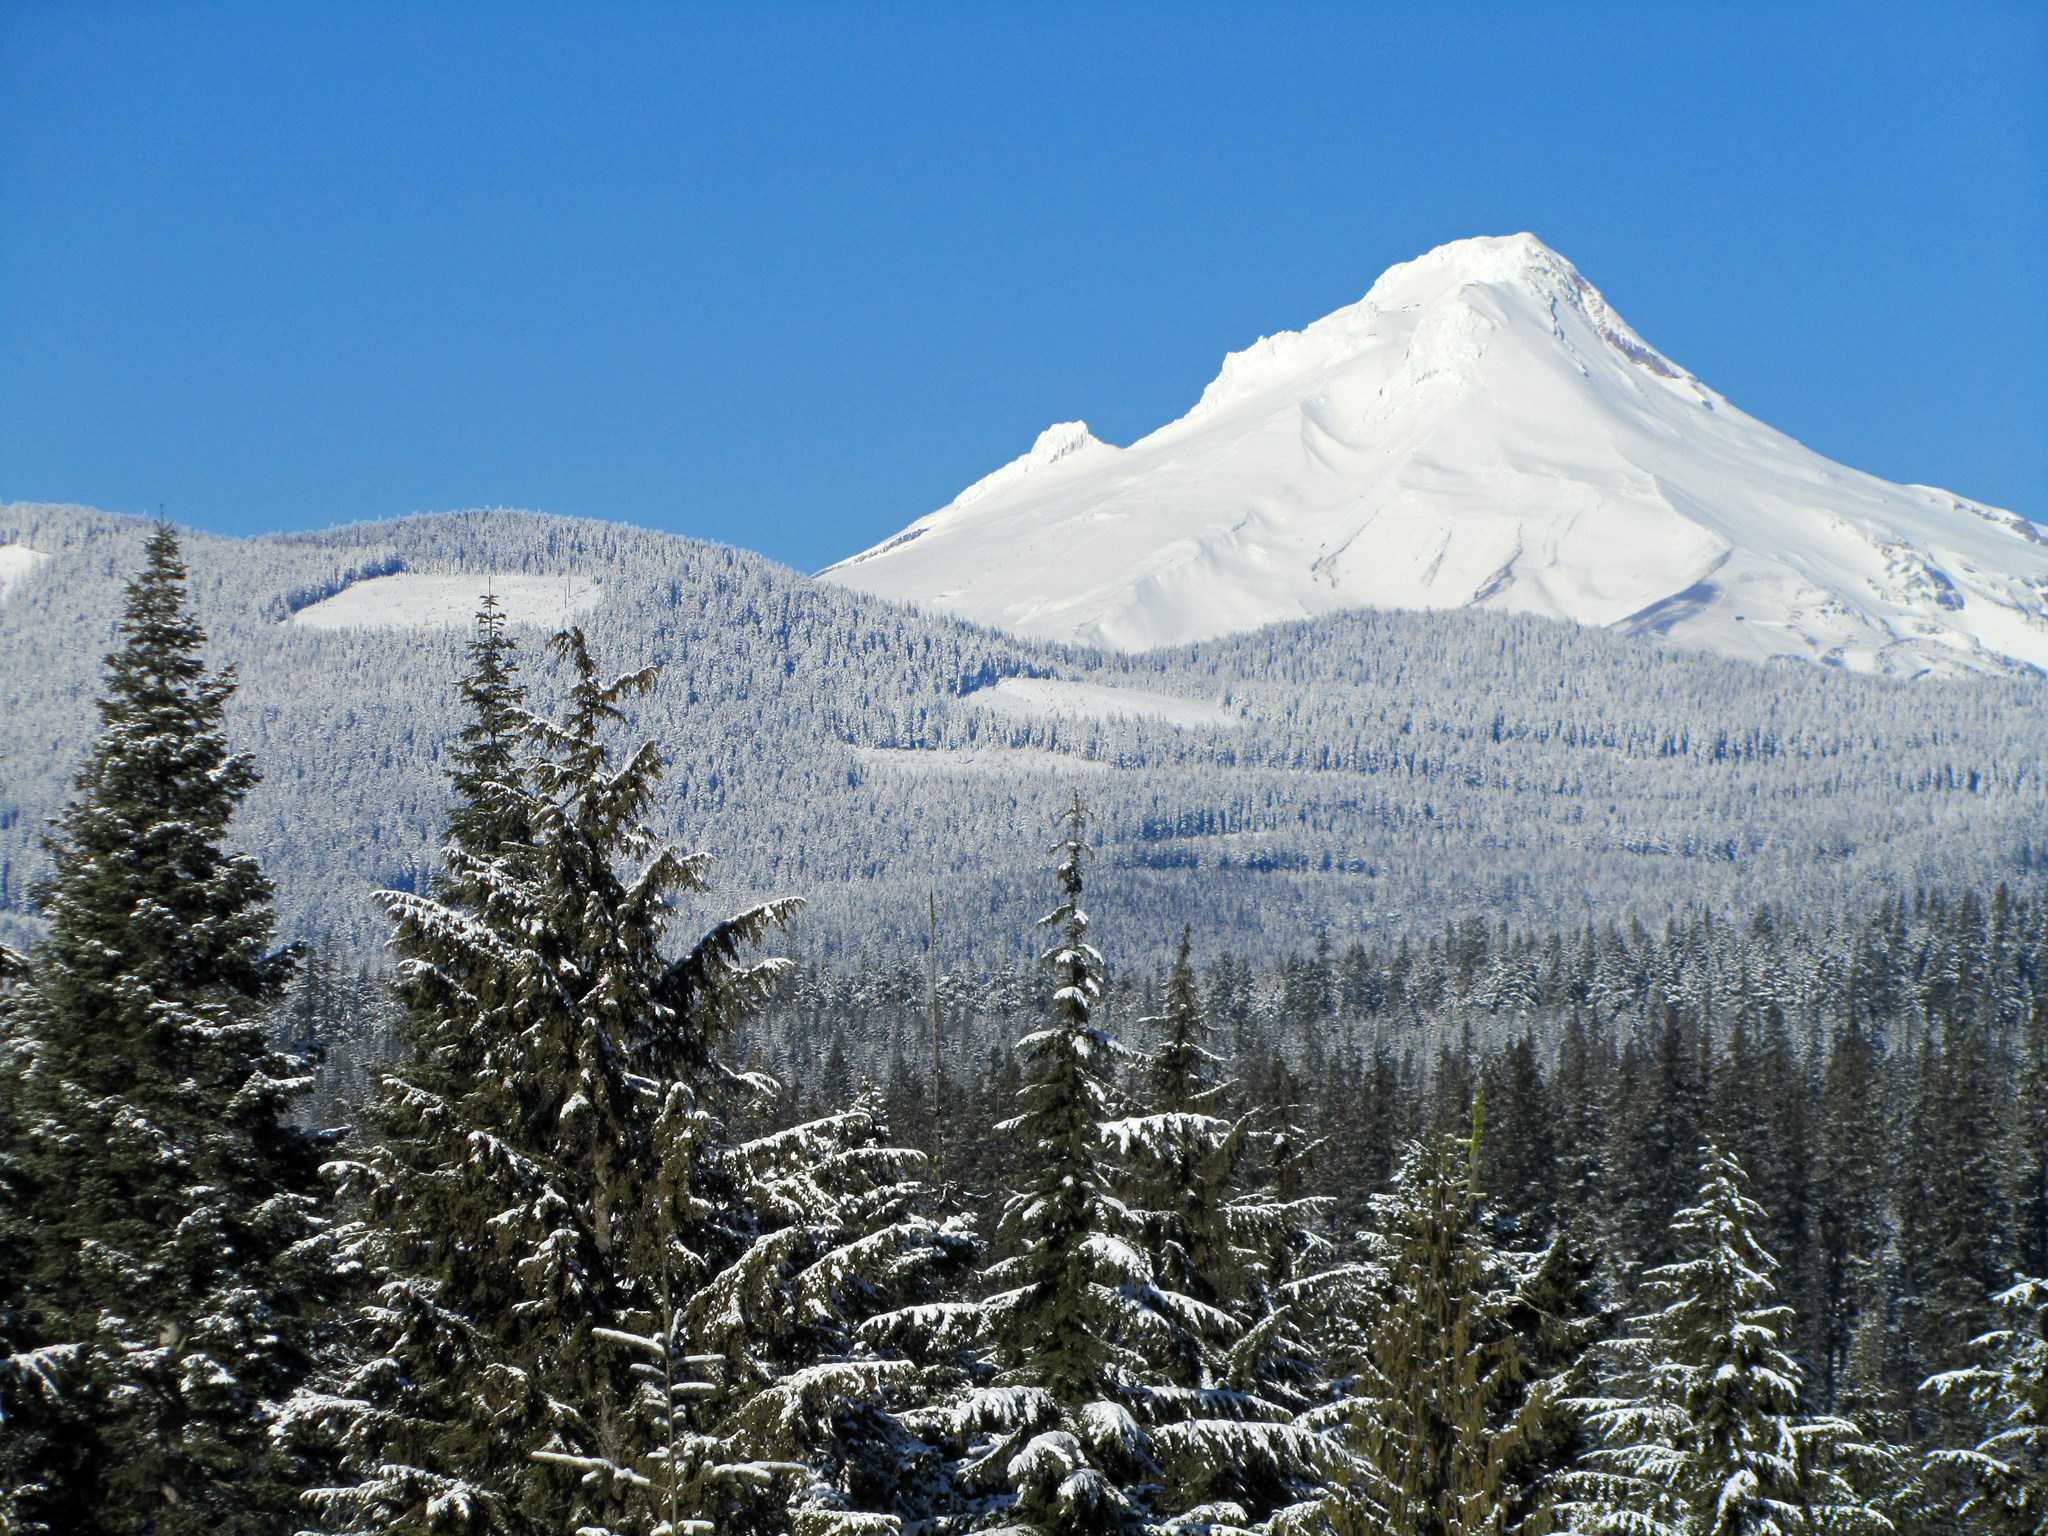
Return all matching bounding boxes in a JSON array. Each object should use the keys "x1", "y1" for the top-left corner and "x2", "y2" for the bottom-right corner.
[{"x1": 821, "y1": 233, "x2": 2048, "y2": 674}]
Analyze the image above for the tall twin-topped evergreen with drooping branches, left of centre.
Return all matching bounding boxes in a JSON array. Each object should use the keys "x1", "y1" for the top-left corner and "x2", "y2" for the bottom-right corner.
[{"x1": 293, "y1": 630, "x2": 801, "y2": 1532}]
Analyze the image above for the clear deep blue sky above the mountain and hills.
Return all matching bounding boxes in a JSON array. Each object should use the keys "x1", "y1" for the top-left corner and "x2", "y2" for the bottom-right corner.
[{"x1": 0, "y1": 0, "x2": 2048, "y2": 569}]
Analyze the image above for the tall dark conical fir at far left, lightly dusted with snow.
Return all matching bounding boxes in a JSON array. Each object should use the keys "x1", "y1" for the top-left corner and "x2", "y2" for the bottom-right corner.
[{"x1": 6, "y1": 524, "x2": 332, "y2": 1536}]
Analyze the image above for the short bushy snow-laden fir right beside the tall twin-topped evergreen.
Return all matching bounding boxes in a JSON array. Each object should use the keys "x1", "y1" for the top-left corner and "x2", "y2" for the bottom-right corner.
[{"x1": 668, "y1": 1087, "x2": 977, "y2": 1536}]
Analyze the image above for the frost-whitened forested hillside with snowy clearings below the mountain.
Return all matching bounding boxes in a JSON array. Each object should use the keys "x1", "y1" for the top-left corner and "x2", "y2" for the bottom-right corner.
[{"x1": 0, "y1": 506, "x2": 2048, "y2": 969}]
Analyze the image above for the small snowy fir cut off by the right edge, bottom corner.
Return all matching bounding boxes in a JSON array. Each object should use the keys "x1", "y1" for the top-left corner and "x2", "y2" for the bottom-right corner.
[{"x1": 1927, "y1": 1280, "x2": 2048, "y2": 1536}]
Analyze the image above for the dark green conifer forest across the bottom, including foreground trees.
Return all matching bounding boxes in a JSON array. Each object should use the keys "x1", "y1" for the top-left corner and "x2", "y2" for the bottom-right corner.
[{"x1": 0, "y1": 524, "x2": 2048, "y2": 1536}]
